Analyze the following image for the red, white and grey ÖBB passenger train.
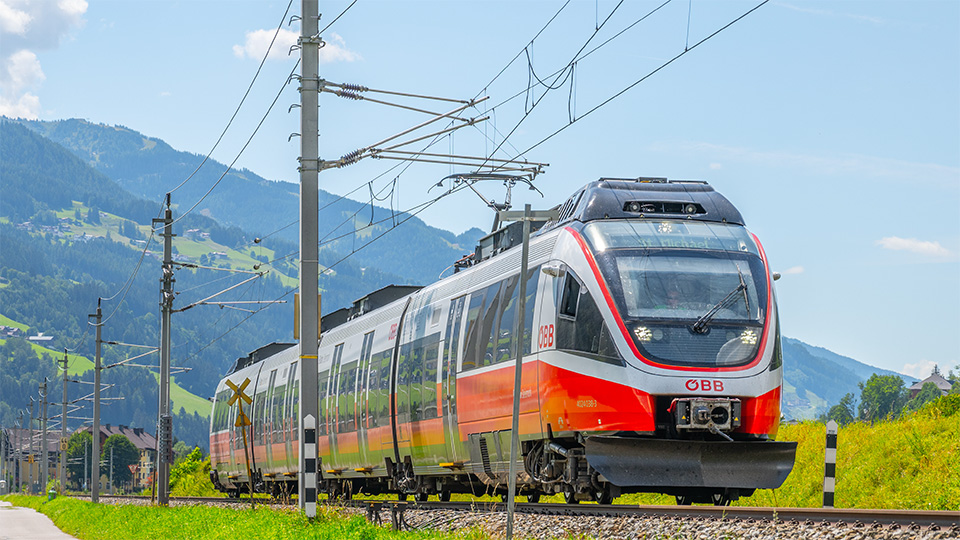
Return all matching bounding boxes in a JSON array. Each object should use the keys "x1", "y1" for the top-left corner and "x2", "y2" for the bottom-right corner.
[{"x1": 210, "y1": 178, "x2": 796, "y2": 504}]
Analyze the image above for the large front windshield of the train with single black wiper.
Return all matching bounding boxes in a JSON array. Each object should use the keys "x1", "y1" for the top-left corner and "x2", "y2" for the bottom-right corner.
[{"x1": 584, "y1": 220, "x2": 768, "y2": 367}]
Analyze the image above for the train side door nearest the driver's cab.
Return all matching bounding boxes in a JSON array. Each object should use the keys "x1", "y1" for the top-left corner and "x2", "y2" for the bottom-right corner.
[{"x1": 440, "y1": 295, "x2": 467, "y2": 461}]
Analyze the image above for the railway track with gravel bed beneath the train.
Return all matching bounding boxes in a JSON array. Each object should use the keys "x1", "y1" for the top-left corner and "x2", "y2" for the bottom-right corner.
[{"x1": 92, "y1": 495, "x2": 960, "y2": 538}]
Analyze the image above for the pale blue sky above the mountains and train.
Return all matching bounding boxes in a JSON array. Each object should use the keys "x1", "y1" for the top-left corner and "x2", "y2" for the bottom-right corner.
[{"x1": 0, "y1": 0, "x2": 960, "y2": 376}]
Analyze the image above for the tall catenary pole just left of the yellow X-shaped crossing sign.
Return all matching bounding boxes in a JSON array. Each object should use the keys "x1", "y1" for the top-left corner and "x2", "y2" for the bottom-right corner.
[{"x1": 153, "y1": 193, "x2": 175, "y2": 506}]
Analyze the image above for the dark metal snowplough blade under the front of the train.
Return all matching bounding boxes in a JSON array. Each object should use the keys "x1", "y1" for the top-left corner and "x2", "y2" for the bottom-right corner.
[{"x1": 584, "y1": 436, "x2": 797, "y2": 489}]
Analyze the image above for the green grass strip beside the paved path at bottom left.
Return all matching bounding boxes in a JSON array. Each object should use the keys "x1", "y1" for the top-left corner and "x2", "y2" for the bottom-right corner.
[{"x1": 3, "y1": 495, "x2": 486, "y2": 540}]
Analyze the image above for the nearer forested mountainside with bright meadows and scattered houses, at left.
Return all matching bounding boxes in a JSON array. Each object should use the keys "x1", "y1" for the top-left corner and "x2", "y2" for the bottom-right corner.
[{"x1": 0, "y1": 120, "x2": 403, "y2": 446}]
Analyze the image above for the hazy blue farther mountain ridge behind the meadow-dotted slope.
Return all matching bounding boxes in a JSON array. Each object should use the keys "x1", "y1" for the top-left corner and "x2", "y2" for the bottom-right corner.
[{"x1": 11, "y1": 119, "x2": 484, "y2": 284}]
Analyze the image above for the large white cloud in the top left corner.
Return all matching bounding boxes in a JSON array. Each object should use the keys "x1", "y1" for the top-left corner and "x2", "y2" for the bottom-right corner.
[{"x1": 0, "y1": 0, "x2": 87, "y2": 119}]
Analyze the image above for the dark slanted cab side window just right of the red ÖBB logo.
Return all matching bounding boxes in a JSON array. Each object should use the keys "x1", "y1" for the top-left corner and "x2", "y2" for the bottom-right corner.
[{"x1": 556, "y1": 269, "x2": 624, "y2": 365}]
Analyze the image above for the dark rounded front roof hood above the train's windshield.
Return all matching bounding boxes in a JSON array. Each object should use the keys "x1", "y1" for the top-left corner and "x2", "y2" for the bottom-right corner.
[{"x1": 543, "y1": 177, "x2": 744, "y2": 231}]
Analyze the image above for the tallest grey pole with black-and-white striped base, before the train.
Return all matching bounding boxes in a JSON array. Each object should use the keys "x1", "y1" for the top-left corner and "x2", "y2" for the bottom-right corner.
[{"x1": 300, "y1": 0, "x2": 321, "y2": 518}]
